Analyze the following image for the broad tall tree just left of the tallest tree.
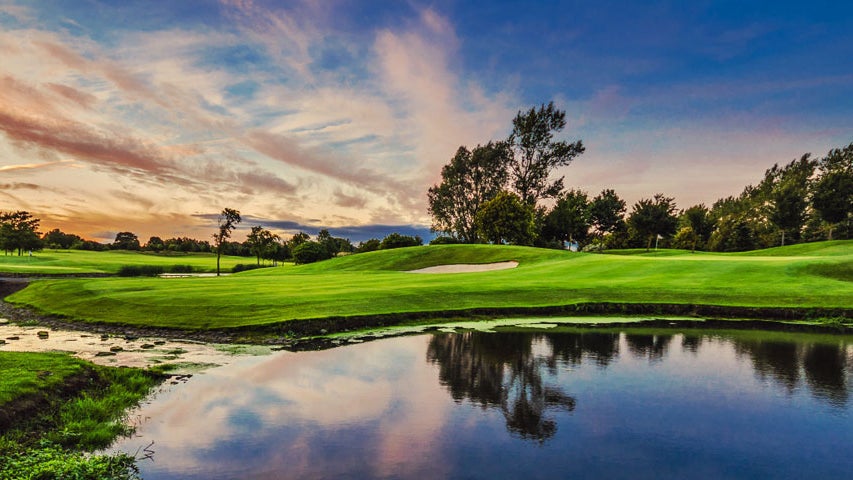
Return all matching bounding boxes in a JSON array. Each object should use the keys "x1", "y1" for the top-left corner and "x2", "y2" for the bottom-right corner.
[{"x1": 427, "y1": 142, "x2": 509, "y2": 243}]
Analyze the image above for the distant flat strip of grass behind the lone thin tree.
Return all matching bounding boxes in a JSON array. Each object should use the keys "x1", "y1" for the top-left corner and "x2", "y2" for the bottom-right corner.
[{"x1": 0, "y1": 250, "x2": 253, "y2": 275}]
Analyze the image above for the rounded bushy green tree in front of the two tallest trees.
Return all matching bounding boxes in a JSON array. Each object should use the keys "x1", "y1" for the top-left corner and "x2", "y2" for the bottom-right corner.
[{"x1": 474, "y1": 191, "x2": 536, "y2": 245}]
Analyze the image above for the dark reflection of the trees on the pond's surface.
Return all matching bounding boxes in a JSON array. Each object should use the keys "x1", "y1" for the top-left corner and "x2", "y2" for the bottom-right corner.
[{"x1": 427, "y1": 330, "x2": 851, "y2": 442}]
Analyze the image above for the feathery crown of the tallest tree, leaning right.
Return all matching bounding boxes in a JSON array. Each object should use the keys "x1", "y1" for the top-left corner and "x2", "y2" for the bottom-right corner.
[{"x1": 507, "y1": 102, "x2": 585, "y2": 206}]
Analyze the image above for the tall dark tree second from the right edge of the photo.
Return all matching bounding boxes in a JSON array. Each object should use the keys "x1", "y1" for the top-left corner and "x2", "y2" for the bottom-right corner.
[{"x1": 768, "y1": 153, "x2": 816, "y2": 245}]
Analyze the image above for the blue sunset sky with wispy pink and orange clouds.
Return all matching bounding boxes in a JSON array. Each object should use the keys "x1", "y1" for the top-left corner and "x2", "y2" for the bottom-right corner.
[{"x1": 0, "y1": 0, "x2": 853, "y2": 243}]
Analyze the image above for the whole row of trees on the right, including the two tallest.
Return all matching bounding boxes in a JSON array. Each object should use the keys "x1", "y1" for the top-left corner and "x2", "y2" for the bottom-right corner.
[{"x1": 427, "y1": 102, "x2": 853, "y2": 252}]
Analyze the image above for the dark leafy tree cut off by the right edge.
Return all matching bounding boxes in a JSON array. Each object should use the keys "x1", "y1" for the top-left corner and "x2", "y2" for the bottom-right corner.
[{"x1": 811, "y1": 143, "x2": 853, "y2": 240}]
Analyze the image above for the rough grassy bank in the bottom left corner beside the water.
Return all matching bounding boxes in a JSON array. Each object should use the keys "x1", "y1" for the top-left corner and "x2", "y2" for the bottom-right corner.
[{"x1": 0, "y1": 352, "x2": 158, "y2": 480}]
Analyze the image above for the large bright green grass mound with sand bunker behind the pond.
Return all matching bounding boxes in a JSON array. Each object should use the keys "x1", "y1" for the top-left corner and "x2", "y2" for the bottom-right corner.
[{"x1": 7, "y1": 241, "x2": 853, "y2": 329}]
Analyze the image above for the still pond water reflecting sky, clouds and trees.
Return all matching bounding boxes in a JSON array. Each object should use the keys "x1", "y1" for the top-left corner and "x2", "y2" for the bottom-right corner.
[{"x1": 115, "y1": 328, "x2": 853, "y2": 480}]
